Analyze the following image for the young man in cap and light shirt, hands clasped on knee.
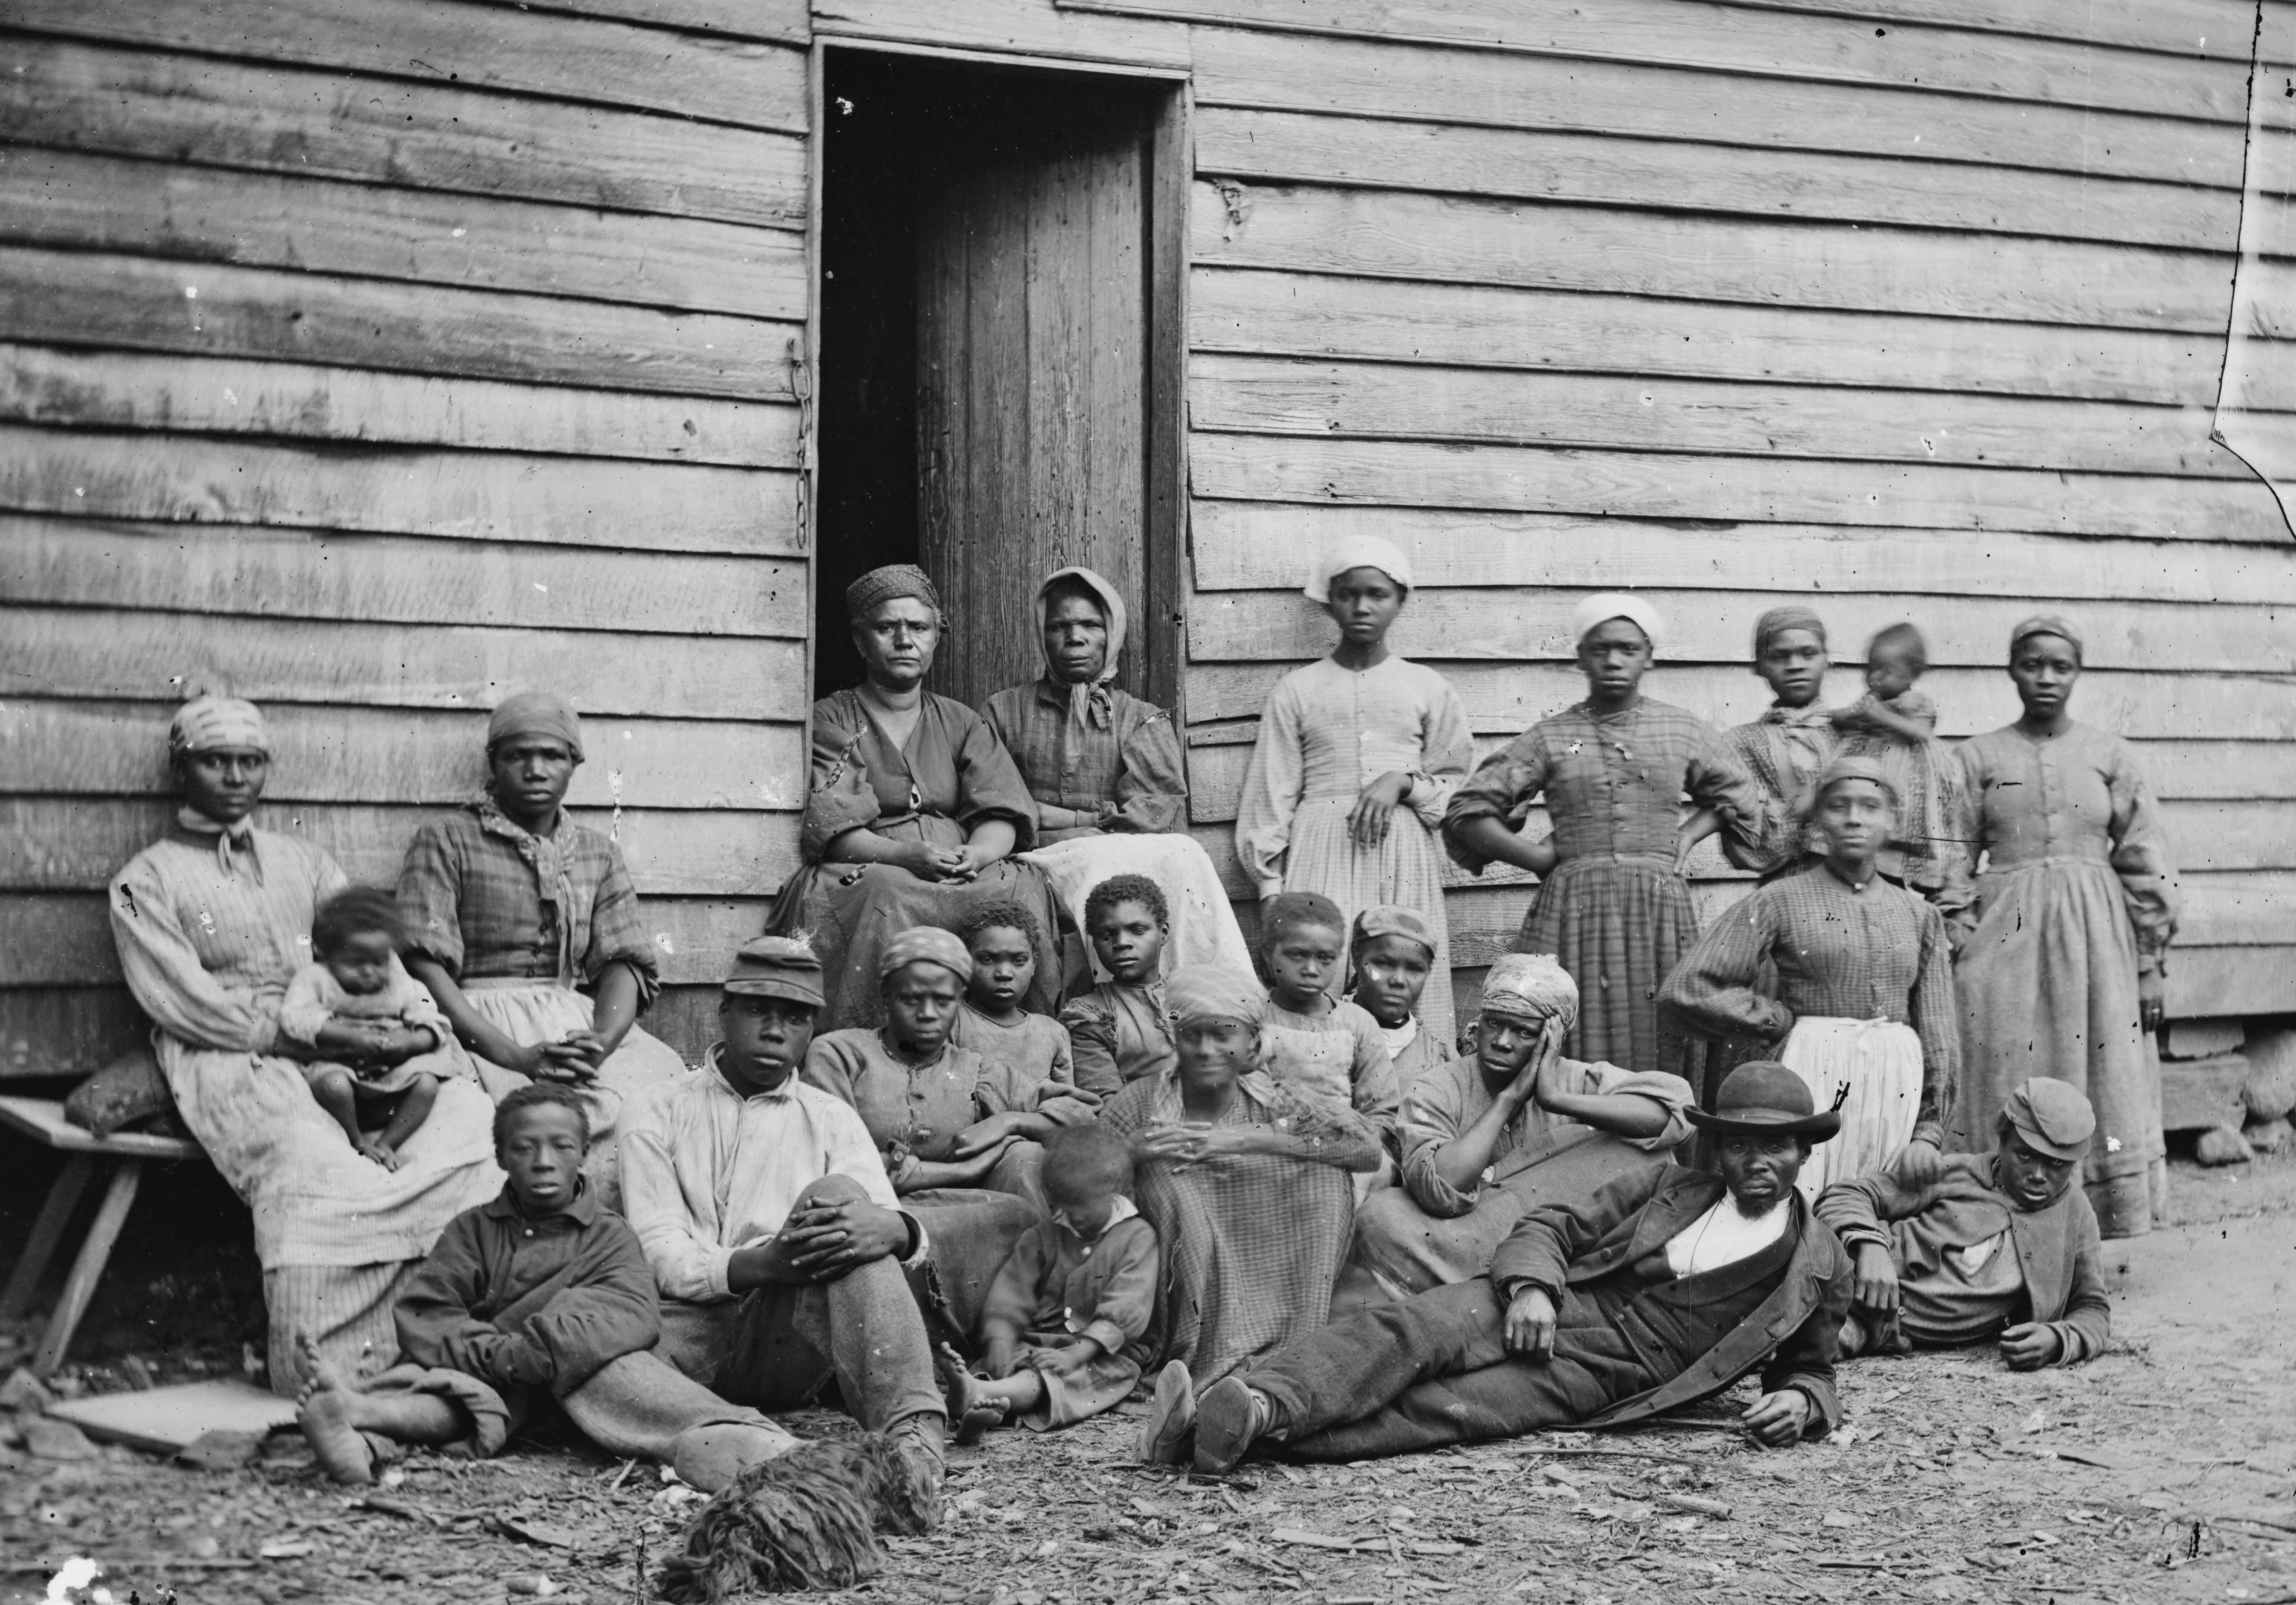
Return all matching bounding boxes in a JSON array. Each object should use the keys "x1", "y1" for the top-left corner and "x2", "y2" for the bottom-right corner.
[{"x1": 622, "y1": 937, "x2": 944, "y2": 1483}]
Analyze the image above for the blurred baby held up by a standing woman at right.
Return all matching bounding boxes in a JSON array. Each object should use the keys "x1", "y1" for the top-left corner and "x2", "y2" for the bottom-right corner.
[{"x1": 1832, "y1": 625, "x2": 1970, "y2": 928}]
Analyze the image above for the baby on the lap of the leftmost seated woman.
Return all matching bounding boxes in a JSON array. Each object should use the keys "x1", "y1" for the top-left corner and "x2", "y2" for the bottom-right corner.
[{"x1": 280, "y1": 886, "x2": 461, "y2": 1171}]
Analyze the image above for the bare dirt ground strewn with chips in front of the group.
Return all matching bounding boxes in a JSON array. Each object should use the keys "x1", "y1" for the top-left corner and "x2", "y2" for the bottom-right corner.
[{"x1": 0, "y1": 1162, "x2": 2296, "y2": 1605}]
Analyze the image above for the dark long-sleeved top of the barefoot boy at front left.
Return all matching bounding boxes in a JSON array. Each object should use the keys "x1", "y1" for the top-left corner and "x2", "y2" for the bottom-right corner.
[{"x1": 393, "y1": 1187, "x2": 661, "y2": 1396}]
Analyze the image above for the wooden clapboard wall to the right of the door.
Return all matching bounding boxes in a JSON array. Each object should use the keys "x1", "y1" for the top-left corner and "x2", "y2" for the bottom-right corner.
[{"x1": 815, "y1": 0, "x2": 2296, "y2": 1015}]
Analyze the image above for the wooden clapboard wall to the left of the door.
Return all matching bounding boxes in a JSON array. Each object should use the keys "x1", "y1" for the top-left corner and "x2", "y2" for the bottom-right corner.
[{"x1": 0, "y1": 0, "x2": 811, "y2": 1075}]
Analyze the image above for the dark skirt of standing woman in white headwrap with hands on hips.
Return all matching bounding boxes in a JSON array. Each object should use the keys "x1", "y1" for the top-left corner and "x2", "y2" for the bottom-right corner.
[{"x1": 1516, "y1": 854, "x2": 1699, "y2": 1075}]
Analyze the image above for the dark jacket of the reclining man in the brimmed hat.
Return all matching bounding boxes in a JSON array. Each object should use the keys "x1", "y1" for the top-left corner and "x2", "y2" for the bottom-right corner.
[{"x1": 1490, "y1": 1169, "x2": 1850, "y2": 1437}]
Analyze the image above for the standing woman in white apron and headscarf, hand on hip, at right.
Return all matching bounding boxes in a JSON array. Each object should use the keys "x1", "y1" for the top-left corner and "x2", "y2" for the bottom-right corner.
[{"x1": 1660, "y1": 755, "x2": 1961, "y2": 1201}]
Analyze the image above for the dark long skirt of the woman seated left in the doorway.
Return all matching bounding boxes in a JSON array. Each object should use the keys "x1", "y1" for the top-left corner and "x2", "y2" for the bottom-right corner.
[{"x1": 767, "y1": 859, "x2": 1061, "y2": 1033}]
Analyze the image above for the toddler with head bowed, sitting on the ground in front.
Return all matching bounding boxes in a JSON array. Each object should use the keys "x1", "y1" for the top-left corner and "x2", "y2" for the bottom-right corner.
[{"x1": 941, "y1": 1125, "x2": 1159, "y2": 1444}]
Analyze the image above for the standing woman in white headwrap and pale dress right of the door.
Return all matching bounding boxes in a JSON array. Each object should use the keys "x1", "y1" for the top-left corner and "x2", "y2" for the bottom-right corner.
[{"x1": 1235, "y1": 535, "x2": 1474, "y2": 1042}]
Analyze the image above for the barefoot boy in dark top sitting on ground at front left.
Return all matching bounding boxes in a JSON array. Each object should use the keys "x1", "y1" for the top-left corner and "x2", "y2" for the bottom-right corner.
[{"x1": 296, "y1": 1081, "x2": 794, "y2": 1488}]
